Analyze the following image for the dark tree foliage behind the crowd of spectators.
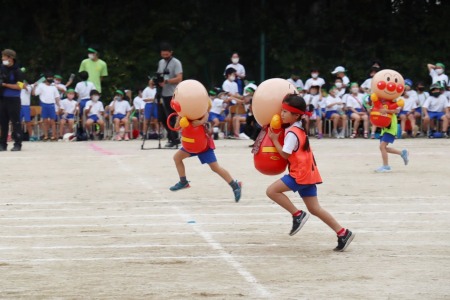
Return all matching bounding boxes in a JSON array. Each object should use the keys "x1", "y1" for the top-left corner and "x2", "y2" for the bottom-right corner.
[{"x1": 0, "y1": 0, "x2": 450, "y2": 101}]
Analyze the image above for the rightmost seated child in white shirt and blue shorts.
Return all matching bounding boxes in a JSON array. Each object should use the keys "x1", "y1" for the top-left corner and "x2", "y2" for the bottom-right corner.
[{"x1": 422, "y1": 83, "x2": 449, "y2": 138}]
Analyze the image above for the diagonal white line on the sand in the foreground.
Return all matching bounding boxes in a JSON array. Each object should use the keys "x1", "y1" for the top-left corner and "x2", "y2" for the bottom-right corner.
[{"x1": 172, "y1": 206, "x2": 270, "y2": 298}]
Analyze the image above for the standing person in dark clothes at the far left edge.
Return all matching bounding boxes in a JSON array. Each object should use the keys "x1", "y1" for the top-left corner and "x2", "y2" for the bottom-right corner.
[{"x1": 0, "y1": 49, "x2": 24, "y2": 151}]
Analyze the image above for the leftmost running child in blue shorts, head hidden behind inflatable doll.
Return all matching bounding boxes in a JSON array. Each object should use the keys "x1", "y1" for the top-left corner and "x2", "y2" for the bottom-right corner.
[{"x1": 170, "y1": 112, "x2": 242, "y2": 202}]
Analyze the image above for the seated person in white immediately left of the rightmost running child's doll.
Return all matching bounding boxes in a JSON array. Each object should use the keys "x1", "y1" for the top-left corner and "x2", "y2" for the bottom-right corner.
[{"x1": 346, "y1": 82, "x2": 369, "y2": 139}]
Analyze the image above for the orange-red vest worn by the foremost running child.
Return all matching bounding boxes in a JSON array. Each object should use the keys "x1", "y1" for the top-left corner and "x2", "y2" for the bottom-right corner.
[{"x1": 288, "y1": 126, "x2": 322, "y2": 184}]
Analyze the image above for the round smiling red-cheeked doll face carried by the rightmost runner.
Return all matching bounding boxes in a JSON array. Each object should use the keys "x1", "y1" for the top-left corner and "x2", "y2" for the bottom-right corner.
[{"x1": 372, "y1": 69, "x2": 405, "y2": 100}]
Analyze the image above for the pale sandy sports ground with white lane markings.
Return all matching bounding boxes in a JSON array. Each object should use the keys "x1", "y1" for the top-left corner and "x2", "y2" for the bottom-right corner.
[{"x1": 0, "y1": 139, "x2": 450, "y2": 299}]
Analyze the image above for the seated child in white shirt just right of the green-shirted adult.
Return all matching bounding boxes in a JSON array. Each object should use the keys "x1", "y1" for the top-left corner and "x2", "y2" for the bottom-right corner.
[{"x1": 110, "y1": 90, "x2": 131, "y2": 141}]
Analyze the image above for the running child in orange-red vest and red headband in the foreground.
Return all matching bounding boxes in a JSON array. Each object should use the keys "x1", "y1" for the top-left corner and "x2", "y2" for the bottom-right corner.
[{"x1": 266, "y1": 94, "x2": 355, "y2": 251}]
